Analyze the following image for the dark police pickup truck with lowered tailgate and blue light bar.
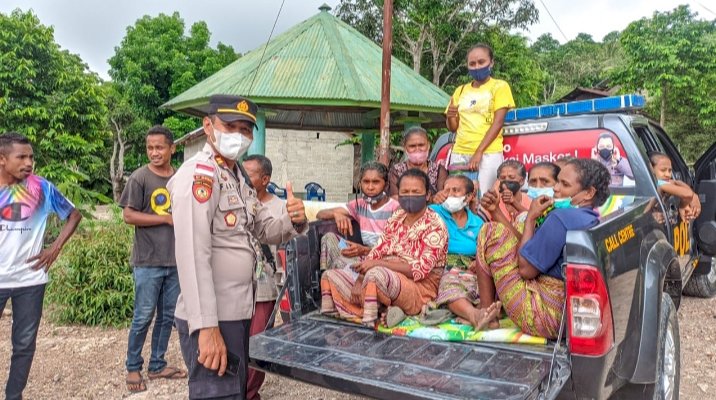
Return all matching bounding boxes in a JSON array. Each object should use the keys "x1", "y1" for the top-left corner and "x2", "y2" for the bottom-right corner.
[{"x1": 250, "y1": 95, "x2": 716, "y2": 400}]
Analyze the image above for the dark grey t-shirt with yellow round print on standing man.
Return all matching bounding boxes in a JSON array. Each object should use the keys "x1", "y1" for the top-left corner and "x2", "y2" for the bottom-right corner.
[{"x1": 119, "y1": 165, "x2": 177, "y2": 267}]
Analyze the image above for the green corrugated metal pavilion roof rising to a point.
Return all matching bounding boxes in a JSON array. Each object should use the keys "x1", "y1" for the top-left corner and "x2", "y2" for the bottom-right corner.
[{"x1": 163, "y1": 6, "x2": 449, "y2": 120}]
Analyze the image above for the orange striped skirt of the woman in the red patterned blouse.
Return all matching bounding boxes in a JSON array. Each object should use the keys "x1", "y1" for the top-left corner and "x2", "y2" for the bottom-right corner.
[{"x1": 321, "y1": 266, "x2": 442, "y2": 324}]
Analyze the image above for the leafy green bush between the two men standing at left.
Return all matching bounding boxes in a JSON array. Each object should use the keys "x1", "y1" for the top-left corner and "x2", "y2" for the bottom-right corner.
[{"x1": 45, "y1": 208, "x2": 134, "y2": 327}]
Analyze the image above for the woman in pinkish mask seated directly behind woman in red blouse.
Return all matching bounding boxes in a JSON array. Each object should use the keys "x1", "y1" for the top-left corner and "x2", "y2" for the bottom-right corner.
[{"x1": 389, "y1": 126, "x2": 448, "y2": 198}]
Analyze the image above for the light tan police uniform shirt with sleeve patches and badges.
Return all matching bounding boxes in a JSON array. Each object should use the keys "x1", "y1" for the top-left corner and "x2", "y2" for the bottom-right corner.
[{"x1": 167, "y1": 144, "x2": 304, "y2": 334}]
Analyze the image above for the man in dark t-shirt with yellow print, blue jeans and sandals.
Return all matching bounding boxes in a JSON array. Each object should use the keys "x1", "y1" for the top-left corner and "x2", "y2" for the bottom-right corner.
[{"x1": 119, "y1": 126, "x2": 186, "y2": 392}]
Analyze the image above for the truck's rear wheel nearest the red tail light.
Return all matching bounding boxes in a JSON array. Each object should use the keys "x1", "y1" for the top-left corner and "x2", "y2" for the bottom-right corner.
[{"x1": 654, "y1": 293, "x2": 681, "y2": 400}]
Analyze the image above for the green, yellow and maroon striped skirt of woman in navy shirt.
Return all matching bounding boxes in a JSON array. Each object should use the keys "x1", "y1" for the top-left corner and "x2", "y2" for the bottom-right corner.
[{"x1": 477, "y1": 222, "x2": 565, "y2": 339}]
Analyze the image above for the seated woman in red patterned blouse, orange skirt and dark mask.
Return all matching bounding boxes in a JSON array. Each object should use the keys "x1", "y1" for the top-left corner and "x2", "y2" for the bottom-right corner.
[{"x1": 321, "y1": 169, "x2": 448, "y2": 327}]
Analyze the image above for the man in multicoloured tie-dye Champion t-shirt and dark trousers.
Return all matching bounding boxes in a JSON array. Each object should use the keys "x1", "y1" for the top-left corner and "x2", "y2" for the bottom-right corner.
[{"x1": 0, "y1": 132, "x2": 82, "y2": 399}]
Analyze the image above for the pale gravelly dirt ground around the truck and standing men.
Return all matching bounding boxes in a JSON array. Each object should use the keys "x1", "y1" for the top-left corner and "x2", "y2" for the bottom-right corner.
[{"x1": 0, "y1": 298, "x2": 716, "y2": 400}]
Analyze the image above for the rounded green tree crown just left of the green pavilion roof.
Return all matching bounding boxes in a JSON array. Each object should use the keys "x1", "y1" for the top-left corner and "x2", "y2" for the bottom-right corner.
[{"x1": 109, "y1": 13, "x2": 238, "y2": 125}]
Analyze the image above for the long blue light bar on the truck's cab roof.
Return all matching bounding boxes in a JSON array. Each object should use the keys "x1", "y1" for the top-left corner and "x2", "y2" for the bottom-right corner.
[{"x1": 505, "y1": 94, "x2": 646, "y2": 122}]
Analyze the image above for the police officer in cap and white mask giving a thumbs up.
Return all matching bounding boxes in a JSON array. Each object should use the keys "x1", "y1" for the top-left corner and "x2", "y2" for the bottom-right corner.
[{"x1": 167, "y1": 95, "x2": 307, "y2": 399}]
